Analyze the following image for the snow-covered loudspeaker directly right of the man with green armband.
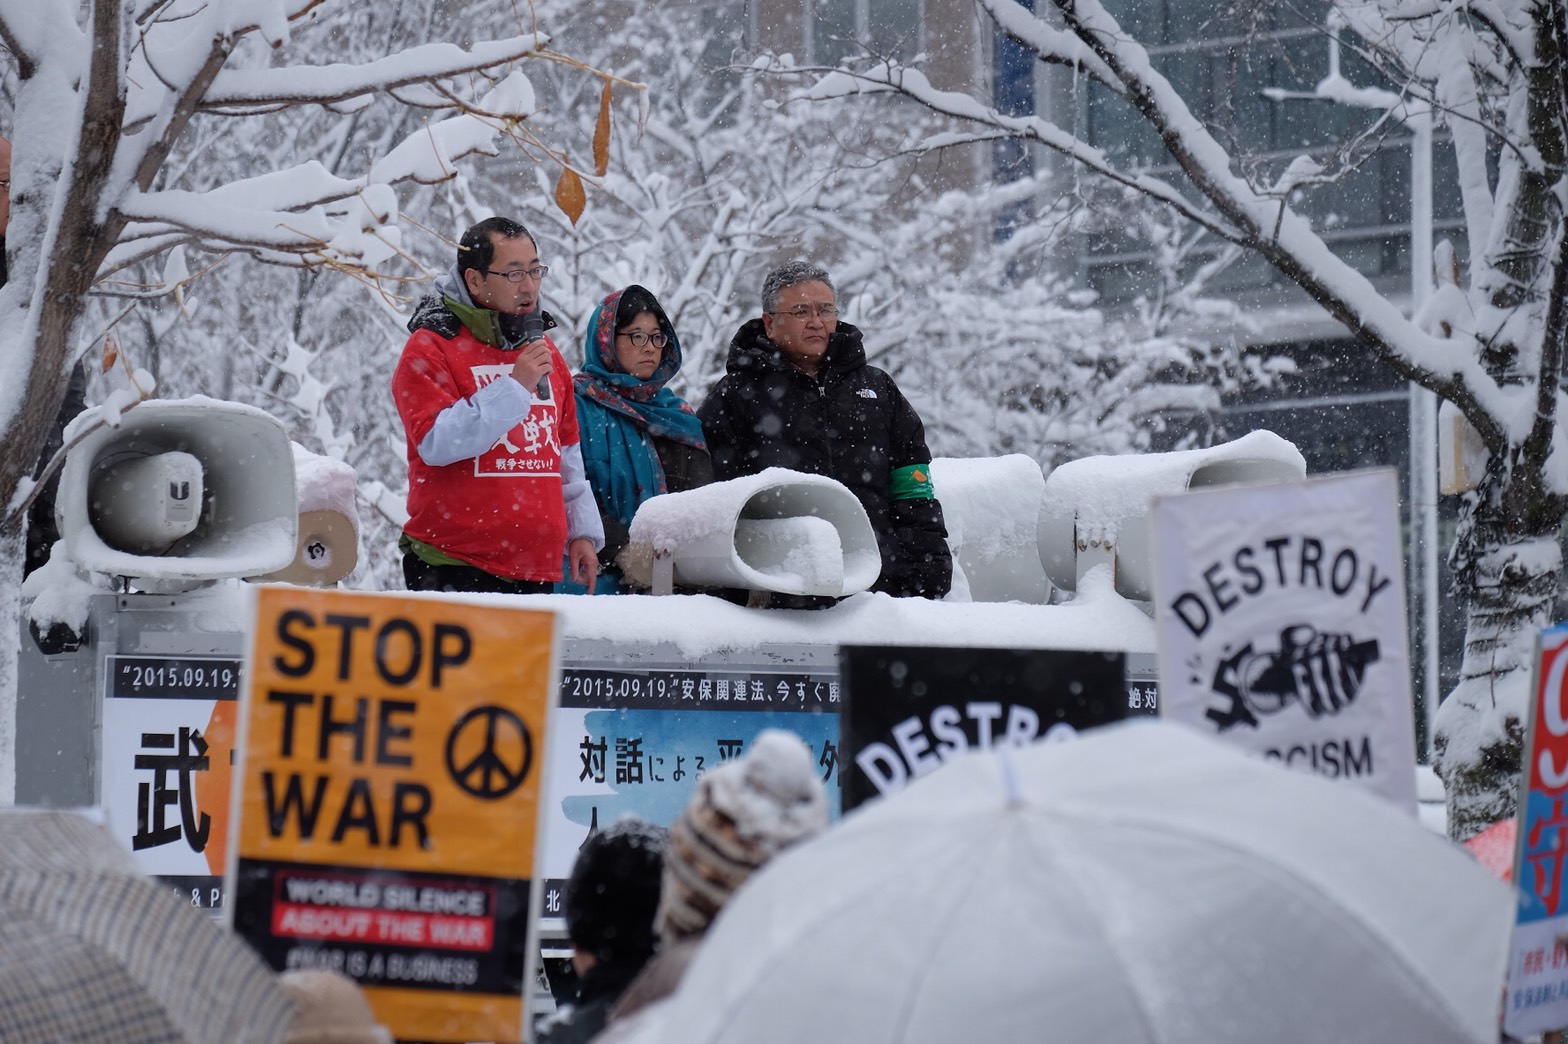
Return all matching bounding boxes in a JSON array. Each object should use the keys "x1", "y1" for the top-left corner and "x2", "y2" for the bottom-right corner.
[{"x1": 931, "y1": 453, "x2": 1051, "y2": 605}]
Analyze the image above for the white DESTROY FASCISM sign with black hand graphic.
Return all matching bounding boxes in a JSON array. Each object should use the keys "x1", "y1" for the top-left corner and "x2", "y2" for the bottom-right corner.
[{"x1": 1152, "y1": 469, "x2": 1416, "y2": 812}]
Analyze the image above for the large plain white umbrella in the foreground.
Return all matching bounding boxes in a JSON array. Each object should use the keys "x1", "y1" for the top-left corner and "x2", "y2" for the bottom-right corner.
[{"x1": 640, "y1": 723, "x2": 1513, "y2": 1044}]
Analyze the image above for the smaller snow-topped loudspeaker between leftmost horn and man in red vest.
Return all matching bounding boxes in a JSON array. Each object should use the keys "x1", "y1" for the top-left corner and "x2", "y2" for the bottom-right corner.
[{"x1": 252, "y1": 442, "x2": 359, "y2": 588}]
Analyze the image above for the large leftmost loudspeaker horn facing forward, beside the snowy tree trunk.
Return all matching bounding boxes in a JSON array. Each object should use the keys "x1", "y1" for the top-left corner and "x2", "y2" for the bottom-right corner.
[{"x1": 55, "y1": 397, "x2": 296, "y2": 582}]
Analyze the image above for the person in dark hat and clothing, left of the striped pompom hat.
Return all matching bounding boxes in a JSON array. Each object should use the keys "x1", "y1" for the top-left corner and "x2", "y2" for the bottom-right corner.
[{"x1": 535, "y1": 815, "x2": 668, "y2": 1044}]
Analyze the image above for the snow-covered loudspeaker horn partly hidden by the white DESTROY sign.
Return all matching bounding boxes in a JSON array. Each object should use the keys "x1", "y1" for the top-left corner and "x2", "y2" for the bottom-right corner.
[{"x1": 1040, "y1": 431, "x2": 1306, "y2": 600}]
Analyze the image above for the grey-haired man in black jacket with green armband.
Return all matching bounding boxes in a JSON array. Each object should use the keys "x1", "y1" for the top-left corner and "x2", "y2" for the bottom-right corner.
[{"x1": 698, "y1": 260, "x2": 953, "y2": 599}]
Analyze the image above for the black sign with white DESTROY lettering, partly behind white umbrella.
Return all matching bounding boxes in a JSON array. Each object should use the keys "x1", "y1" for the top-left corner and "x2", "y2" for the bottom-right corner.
[{"x1": 839, "y1": 646, "x2": 1135, "y2": 812}]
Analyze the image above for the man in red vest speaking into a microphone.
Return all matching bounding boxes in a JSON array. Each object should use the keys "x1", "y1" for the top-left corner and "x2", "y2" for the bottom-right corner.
[{"x1": 392, "y1": 218, "x2": 604, "y2": 594}]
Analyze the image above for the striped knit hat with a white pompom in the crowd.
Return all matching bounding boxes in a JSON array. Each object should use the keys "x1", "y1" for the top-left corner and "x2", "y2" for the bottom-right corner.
[{"x1": 659, "y1": 729, "x2": 828, "y2": 942}]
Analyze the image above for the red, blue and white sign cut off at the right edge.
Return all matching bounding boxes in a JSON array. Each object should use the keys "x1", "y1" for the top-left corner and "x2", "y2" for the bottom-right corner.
[{"x1": 1502, "y1": 624, "x2": 1568, "y2": 1036}]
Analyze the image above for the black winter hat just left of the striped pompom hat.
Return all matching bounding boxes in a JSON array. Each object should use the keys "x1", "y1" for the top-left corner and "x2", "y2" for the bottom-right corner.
[{"x1": 566, "y1": 815, "x2": 670, "y2": 964}]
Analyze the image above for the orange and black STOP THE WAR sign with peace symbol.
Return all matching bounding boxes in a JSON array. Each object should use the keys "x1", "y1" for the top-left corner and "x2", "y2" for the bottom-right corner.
[{"x1": 229, "y1": 588, "x2": 558, "y2": 1041}]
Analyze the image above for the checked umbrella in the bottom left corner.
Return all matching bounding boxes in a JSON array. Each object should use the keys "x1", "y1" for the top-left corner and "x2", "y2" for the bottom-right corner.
[{"x1": 0, "y1": 810, "x2": 293, "y2": 1044}]
